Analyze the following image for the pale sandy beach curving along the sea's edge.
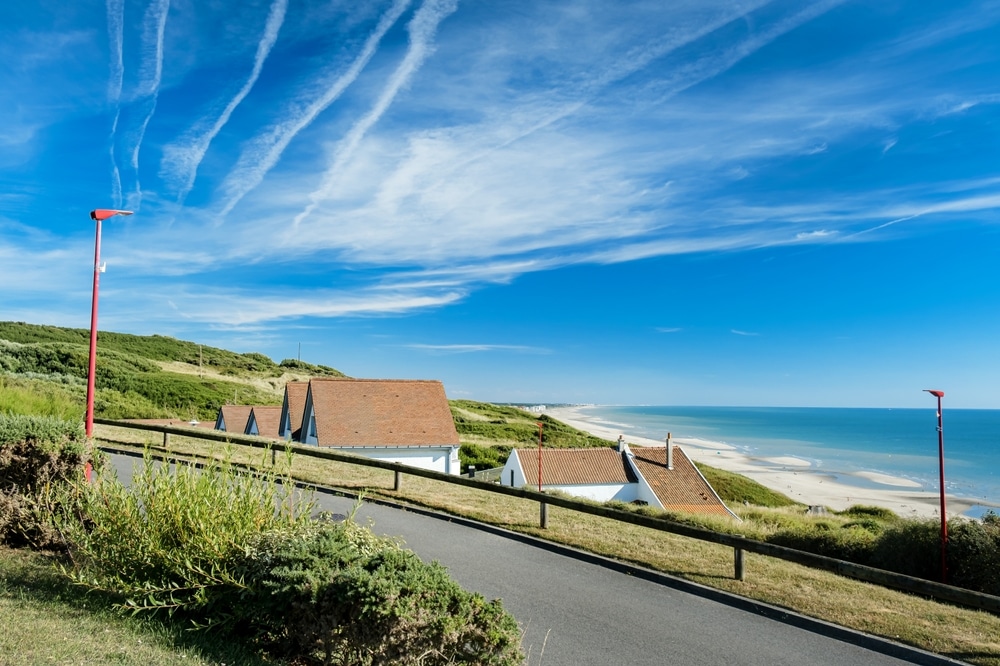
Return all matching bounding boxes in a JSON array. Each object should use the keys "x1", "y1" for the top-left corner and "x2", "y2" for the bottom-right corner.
[{"x1": 546, "y1": 407, "x2": 973, "y2": 520}]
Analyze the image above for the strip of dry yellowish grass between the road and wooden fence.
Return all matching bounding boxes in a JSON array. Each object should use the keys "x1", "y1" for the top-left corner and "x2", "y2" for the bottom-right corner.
[{"x1": 99, "y1": 426, "x2": 1000, "y2": 666}]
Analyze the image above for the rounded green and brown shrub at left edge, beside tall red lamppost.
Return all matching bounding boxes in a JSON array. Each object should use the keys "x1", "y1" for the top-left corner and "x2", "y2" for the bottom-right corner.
[{"x1": 0, "y1": 414, "x2": 93, "y2": 548}]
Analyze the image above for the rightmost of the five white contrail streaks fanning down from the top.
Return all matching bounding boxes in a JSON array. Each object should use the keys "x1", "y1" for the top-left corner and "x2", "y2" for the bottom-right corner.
[{"x1": 292, "y1": 0, "x2": 458, "y2": 227}]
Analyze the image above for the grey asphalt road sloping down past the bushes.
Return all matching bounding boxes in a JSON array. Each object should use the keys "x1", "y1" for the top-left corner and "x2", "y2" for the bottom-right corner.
[{"x1": 105, "y1": 456, "x2": 958, "y2": 666}]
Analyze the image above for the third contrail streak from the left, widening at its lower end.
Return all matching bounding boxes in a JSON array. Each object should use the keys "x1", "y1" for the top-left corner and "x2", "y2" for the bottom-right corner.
[{"x1": 163, "y1": 0, "x2": 288, "y2": 204}]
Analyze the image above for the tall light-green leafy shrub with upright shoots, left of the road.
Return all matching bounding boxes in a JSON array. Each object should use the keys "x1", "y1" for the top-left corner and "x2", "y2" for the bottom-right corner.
[{"x1": 54, "y1": 446, "x2": 312, "y2": 622}]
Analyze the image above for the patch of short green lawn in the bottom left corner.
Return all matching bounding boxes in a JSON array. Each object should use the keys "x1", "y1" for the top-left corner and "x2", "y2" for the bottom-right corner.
[{"x1": 0, "y1": 548, "x2": 281, "y2": 666}]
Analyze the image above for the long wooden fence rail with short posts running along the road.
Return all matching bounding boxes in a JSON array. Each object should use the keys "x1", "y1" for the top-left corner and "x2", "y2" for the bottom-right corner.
[{"x1": 94, "y1": 419, "x2": 1000, "y2": 615}]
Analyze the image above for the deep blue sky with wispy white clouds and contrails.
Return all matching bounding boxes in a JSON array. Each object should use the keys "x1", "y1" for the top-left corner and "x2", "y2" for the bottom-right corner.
[{"x1": 0, "y1": 0, "x2": 1000, "y2": 408}]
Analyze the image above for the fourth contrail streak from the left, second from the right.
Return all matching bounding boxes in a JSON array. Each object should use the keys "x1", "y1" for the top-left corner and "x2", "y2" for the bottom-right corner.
[{"x1": 220, "y1": 0, "x2": 410, "y2": 217}]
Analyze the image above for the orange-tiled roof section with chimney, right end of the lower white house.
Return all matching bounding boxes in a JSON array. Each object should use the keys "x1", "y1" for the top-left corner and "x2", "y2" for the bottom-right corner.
[{"x1": 629, "y1": 446, "x2": 735, "y2": 518}]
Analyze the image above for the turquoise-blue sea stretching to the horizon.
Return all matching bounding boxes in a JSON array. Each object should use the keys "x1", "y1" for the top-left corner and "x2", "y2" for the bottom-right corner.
[{"x1": 581, "y1": 404, "x2": 1000, "y2": 518}]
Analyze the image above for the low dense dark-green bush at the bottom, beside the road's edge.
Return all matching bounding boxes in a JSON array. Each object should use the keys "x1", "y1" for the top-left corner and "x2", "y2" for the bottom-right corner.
[{"x1": 243, "y1": 520, "x2": 523, "y2": 666}]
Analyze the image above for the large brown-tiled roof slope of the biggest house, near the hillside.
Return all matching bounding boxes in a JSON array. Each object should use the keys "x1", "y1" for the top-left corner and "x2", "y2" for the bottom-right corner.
[{"x1": 308, "y1": 378, "x2": 459, "y2": 447}]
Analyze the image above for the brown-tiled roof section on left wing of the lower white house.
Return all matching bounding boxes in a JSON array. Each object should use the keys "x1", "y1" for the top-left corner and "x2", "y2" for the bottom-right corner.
[{"x1": 514, "y1": 448, "x2": 637, "y2": 486}]
